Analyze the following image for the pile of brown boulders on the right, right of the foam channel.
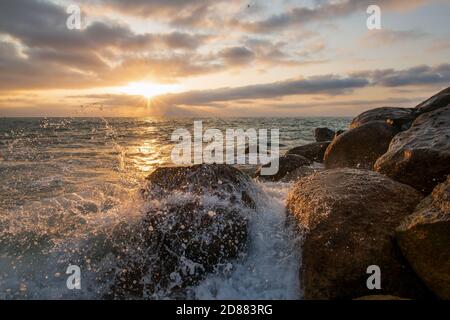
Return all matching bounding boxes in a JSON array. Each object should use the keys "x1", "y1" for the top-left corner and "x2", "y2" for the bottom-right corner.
[{"x1": 287, "y1": 88, "x2": 450, "y2": 299}]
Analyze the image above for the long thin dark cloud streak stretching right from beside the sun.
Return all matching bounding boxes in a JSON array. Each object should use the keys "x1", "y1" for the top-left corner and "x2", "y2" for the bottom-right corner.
[{"x1": 77, "y1": 64, "x2": 450, "y2": 106}]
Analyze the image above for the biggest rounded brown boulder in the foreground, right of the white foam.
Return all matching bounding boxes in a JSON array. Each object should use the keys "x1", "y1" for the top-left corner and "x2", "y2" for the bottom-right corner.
[{"x1": 287, "y1": 168, "x2": 428, "y2": 299}]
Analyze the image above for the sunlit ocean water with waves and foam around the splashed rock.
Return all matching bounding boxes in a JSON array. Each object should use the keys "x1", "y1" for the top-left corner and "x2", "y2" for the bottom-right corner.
[{"x1": 0, "y1": 117, "x2": 351, "y2": 299}]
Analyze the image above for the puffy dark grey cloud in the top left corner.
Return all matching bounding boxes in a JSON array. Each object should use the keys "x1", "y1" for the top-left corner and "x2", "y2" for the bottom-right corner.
[{"x1": 0, "y1": 0, "x2": 208, "y2": 51}]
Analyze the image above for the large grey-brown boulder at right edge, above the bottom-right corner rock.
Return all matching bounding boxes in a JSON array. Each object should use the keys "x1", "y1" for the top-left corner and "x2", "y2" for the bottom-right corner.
[{"x1": 374, "y1": 106, "x2": 450, "y2": 194}]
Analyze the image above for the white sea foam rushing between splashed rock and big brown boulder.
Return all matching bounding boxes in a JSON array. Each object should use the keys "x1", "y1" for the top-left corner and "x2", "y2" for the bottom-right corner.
[{"x1": 192, "y1": 183, "x2": 300, "y2": 300}]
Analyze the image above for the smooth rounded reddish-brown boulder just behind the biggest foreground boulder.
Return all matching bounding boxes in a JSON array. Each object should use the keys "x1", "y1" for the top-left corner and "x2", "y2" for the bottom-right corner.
[{"x1": 324, "y1": 121, "x2": 397, "y2": 169}]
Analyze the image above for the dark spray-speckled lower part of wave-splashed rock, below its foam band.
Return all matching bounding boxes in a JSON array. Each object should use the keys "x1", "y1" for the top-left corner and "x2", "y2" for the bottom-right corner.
[{"x1": 108, "y1": 200, "x2": 248, "y2": 299}]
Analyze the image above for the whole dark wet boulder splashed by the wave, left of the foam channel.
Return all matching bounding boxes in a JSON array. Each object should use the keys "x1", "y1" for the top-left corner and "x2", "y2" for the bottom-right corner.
[{"x1": 106, "y1": 165, "x2": 255, "y2": 298}]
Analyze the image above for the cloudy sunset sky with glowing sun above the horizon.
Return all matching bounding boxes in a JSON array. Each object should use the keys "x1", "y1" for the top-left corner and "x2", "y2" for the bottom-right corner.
[{"x1": 0, "y1": 0, "x2": 450, "y2": 117}]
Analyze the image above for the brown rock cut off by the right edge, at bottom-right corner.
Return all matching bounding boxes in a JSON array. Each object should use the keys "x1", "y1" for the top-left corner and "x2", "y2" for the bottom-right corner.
[{"x1": 397, "y1": 176, "x2": 450, "y2": 300}]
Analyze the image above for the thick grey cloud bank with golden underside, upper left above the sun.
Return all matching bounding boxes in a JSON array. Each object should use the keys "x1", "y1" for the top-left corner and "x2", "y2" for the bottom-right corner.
[{"x1": 0, "y1": 0, "x2": 217, "y2": 90}]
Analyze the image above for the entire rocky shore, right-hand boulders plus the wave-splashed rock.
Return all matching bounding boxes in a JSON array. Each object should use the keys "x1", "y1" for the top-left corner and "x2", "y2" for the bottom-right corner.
[{"x1": 108, "y1": 88, "x2": 450, "y2": 300}]
